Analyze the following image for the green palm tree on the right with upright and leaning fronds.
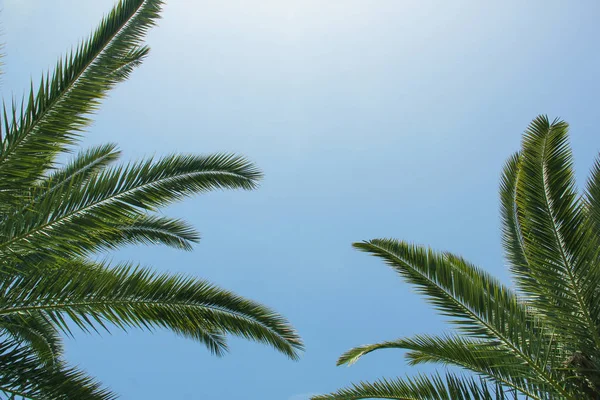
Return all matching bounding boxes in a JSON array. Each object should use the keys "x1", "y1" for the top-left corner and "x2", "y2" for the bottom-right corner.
[{"x1": 313, "y1": 116, "x2": 600, "y2": 400}]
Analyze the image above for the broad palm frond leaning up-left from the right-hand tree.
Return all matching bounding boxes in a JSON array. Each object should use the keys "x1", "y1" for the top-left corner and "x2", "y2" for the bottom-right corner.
[{"x1": 354, "y1": 239, "x2": 568, "y2": 398}]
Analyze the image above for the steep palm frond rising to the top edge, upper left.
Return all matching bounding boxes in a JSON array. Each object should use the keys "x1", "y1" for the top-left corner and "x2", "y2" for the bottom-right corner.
[{"x1": 0, "y1": 0, "x2": 162, "y2": 197}]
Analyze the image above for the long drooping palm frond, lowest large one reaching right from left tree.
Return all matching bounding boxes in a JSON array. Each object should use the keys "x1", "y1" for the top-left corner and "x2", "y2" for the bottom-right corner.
[{"x1": 0, "y1": 262, "x2": 302, "y2": 359}]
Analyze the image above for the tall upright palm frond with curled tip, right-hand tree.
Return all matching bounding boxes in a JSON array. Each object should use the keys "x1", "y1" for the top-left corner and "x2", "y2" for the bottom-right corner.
[{"x1": 517, "y1": 116, "x2": 600, "y2": 356}]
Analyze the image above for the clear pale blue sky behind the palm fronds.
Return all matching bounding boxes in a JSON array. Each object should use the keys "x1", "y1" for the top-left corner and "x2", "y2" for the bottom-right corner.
[{"x1": 0, "y1": 0, "x2": 600, "y2": 400}]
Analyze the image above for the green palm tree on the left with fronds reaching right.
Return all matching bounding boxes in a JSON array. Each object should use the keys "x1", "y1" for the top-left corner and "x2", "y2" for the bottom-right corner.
[{"x1": 0, "y1": 0, "x2": 302, "y2": 399}]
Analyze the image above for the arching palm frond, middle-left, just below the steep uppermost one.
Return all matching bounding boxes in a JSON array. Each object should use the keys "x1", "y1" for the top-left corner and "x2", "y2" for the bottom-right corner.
[{"x1": 0, "y1": 154, "x2": 261, "y2": 256}]
